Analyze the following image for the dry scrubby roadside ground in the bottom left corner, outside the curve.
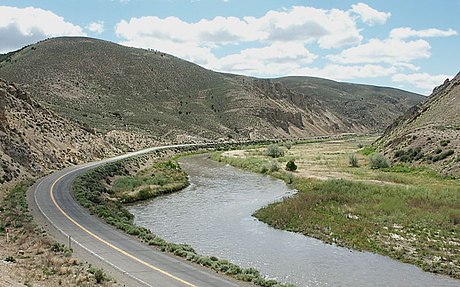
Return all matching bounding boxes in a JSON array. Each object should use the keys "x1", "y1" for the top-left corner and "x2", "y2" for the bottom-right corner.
[{"x1": 0, "y1": 181, "x2": 114, "y2": 286}]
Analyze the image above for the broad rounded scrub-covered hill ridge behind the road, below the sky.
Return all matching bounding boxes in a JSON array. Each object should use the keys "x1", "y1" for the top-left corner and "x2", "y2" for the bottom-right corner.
[{"x1": 0, "y1": 37, "x2": 423, "y2": 143}]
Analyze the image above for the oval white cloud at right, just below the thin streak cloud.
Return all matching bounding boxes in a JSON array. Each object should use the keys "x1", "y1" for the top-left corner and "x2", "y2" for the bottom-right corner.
[{"x1": 328, "y1": 38, "x2": 431, "y2": 64}]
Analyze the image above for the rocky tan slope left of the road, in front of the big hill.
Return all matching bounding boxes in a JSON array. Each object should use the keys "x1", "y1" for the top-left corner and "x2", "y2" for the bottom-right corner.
[{"x1": 0, "y1": 80, "x2": 118, "y2": 189}]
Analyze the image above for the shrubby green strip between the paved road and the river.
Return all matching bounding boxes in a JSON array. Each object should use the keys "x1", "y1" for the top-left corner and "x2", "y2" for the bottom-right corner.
[{"x1": 73, "y1": 151, "x2": 293, "y2": 287}]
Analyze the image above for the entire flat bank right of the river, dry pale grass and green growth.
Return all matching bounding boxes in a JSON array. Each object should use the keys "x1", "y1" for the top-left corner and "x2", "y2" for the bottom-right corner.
[{"x1": 213, "y1": 140, "x2": 460, "y2": 278}]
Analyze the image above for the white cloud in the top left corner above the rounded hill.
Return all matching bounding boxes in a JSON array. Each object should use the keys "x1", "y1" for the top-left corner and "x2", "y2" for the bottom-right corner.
[{"x1": 0, "y1": 6, "x2": 85, "y2": 52}]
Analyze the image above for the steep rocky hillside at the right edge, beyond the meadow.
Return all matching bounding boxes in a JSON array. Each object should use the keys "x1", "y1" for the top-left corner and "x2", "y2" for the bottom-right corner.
[{"x1": 376, "y1": 73, "x2": 460, "y2": 176}]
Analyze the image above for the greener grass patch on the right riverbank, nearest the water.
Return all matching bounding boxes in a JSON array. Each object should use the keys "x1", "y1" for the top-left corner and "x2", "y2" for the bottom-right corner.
[{"x1": 255, "y1": 178, "x2": 460, "y2": 278}]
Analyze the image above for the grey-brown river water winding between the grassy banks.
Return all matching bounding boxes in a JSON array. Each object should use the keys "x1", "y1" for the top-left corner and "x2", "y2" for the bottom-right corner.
[{"x1": 129, "y1": 156, "x2": 460, "y2": 287}]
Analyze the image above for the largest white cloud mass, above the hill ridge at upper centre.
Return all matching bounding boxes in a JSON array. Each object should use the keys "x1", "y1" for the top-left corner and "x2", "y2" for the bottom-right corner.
[{"x1": 115, "y1": 6, "x2": 363, "y2": 75}]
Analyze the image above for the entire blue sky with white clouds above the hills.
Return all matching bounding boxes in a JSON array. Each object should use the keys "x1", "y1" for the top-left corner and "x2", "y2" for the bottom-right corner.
[{"x1": 0, "y1": 0, "x2": 460, "y2": 95}]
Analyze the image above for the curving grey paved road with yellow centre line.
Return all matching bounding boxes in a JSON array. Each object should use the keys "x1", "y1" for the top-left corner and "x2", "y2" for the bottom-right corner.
[{"x1": 31, "y1": 145, "x2": 239, "y2": 287}]
